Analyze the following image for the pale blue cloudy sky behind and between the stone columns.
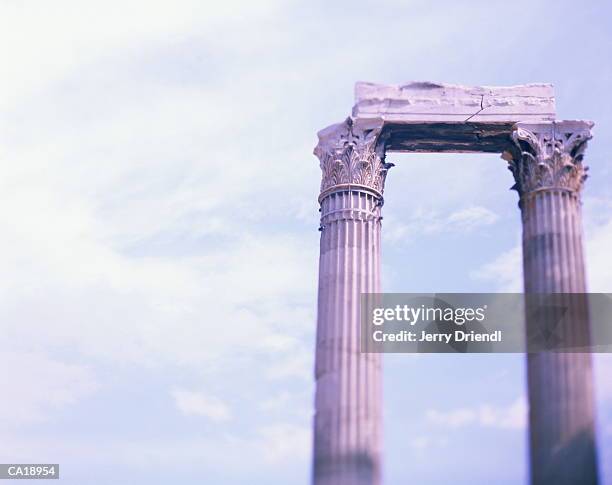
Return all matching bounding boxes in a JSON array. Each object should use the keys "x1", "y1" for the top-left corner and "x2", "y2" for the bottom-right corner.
[{"x1": 0, "y1": 0, "x2": 612, "y2": 485}]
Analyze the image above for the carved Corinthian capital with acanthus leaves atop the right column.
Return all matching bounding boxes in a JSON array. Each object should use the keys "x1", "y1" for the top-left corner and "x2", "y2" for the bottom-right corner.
[{"x1": 502, "y1": 121, "x2": 593, "y2": 197}]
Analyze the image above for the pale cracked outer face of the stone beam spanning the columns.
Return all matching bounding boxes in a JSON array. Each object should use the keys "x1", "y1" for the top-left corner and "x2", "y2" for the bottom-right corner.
[{"x1": 353, "y1": 82, "x2": 555, "y2": 123}]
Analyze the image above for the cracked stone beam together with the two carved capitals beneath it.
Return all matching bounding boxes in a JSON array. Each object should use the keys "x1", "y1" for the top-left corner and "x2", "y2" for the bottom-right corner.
[{"x1": 315, "y1": 82, "x2": 592, "y2": 198}]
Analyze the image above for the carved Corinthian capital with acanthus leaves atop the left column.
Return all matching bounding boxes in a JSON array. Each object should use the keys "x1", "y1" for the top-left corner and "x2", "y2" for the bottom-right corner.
[{"x1": 314, "y1": 118, "x2": 393, "y2": 197}]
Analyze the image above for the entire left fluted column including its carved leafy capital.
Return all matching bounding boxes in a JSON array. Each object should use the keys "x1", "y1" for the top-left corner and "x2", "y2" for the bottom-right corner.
[{"x1": 313, "y1": 118, "x2": 391, "y2": 485}]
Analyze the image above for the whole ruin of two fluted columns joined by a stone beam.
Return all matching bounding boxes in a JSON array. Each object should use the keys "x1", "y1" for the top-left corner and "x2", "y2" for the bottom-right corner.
[{"x1": 312, "y1": 82, "x2": 599, "y2": 485}]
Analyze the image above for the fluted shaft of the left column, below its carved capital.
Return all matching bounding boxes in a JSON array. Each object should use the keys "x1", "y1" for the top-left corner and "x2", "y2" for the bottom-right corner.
[{"x1": 314, "y1": 191, "x2": 381, "y2": 485}]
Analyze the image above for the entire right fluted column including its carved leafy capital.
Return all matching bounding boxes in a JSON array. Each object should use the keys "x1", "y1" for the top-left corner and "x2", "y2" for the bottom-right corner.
[{"x1": 504, "y1": 121, "x2": 598, "y2": 485}]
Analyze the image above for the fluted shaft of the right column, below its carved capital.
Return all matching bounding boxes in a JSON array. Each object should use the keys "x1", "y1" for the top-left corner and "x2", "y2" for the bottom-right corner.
[{"x1": 522, "y1": 190, "x2": 597, "y2": 485}]
